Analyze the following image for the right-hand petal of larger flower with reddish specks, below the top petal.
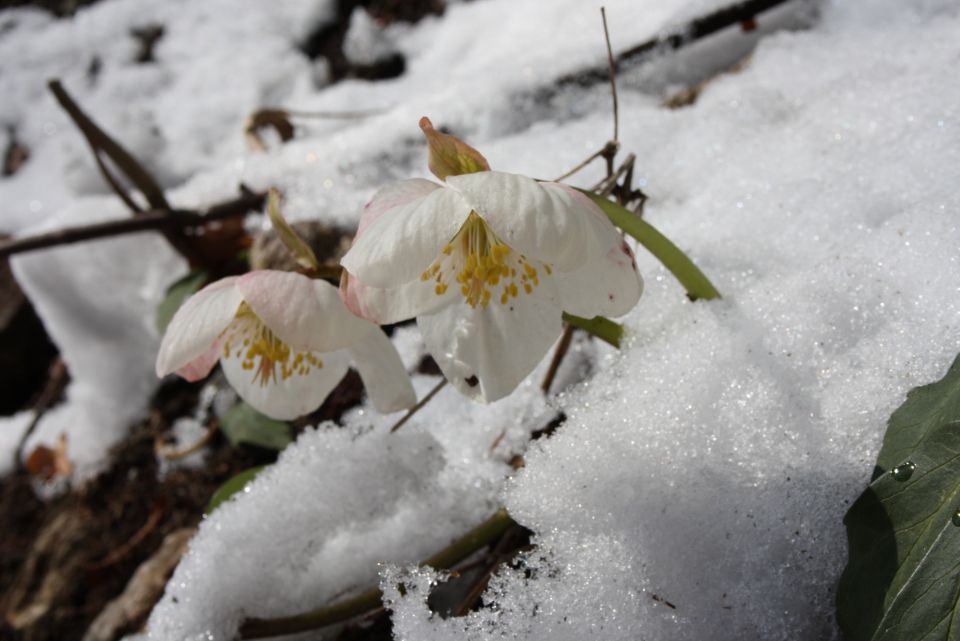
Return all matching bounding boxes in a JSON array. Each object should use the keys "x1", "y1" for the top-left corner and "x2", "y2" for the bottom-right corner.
[{"x1": 554, "y1": 238, "x2": 643, "y2": 318}]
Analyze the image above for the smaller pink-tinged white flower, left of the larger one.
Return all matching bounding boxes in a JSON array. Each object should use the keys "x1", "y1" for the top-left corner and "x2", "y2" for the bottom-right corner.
[{"x1": 157, "y1": 270, "x2": 416, "y2": 419}]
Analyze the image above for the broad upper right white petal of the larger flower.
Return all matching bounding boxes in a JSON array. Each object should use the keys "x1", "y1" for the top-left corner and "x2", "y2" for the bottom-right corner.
[{"x1": 447, "y1": 171, "x2": 617, "y2": 271}]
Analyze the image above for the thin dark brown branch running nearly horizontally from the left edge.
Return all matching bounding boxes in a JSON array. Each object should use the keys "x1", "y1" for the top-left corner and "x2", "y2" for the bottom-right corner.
[{"x1": 0, "y1": 193, "x2": 266, "y2": 258}]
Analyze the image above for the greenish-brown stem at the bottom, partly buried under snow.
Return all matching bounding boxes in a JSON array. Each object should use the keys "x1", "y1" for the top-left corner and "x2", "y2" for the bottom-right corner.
[{"x1": 240, "y1": 509, "x2": 514, "y2": 639}]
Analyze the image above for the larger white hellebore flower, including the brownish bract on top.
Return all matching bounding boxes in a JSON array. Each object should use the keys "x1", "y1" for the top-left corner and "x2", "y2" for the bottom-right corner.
[{"x1": 341, "y1": 119, "x2": 642, "y2": 401}]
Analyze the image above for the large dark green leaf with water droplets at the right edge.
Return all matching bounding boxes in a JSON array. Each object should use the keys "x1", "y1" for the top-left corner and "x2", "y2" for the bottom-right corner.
[{"x1": 837, "y1": 357, "x2": 960, "y2": 641}]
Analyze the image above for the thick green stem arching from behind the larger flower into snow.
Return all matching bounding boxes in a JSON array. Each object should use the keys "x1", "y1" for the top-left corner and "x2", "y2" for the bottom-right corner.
[{"x1": 578, "y1": 189, "x2": 720, "y2": 300}]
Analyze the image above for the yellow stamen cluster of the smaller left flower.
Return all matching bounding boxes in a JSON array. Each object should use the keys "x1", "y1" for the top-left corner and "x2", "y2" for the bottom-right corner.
[{"x1": 222, "y1": 303, "x2": 323, "y2": 386}]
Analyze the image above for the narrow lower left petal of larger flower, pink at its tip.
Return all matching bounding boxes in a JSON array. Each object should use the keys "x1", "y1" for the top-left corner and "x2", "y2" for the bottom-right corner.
[{"x1": 340, "y1": 273, "x2": 459, "y2": 325}]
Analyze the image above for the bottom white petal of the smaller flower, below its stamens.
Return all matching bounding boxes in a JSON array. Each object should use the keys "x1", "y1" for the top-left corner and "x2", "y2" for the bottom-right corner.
[{"x1": 220, "y1": 344, "x2": 350, "y2": 421}]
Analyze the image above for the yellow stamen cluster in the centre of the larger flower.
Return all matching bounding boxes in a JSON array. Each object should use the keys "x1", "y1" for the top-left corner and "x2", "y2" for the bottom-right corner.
[{"x1": 420, "y1": 212, "x2": 553, "y2": 309}]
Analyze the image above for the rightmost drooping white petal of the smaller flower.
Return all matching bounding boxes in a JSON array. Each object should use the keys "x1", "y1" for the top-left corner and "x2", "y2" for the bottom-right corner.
[{"x1": 347, "y1": 323, "x2": 417, "y2": 414}]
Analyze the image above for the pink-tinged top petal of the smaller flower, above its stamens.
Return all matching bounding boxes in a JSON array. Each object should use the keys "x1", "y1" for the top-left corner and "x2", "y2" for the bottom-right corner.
[{"x1": 237, "y1": 270, "x2": 363, "y2": 352}]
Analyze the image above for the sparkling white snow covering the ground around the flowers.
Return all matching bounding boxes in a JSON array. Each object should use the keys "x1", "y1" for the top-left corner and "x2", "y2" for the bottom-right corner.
[{"x1": 0, "y1": 0, "x2": 960, "y2": 641}]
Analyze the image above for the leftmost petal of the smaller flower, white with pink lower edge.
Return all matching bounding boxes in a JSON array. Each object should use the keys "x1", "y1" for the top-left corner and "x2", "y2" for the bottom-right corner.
[{"x1": 157, "y1": 276, "x2": 243, "y2": 376}]
